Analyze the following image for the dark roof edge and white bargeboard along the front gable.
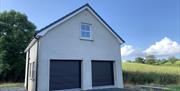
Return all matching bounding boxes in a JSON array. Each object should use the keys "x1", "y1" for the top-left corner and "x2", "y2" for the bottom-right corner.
[{"x1": 36, "y1": 4, "x2": 125, "y2": 44}]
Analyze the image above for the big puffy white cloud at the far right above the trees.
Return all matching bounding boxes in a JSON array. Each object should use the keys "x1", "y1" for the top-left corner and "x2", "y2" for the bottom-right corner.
[{"x1": 143, "y1": 37, "x2": 180, "y2": 56}]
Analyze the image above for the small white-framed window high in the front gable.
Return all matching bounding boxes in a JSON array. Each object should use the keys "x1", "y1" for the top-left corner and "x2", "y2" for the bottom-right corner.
[{"x1": 81, "y1": 23, "x2": 91, "y2": 39}]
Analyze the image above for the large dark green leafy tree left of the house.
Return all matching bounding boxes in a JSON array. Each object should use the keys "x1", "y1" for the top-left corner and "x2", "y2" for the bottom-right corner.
[{"x1": 0, "y1": 10, "x2": 36, "y2": 81}]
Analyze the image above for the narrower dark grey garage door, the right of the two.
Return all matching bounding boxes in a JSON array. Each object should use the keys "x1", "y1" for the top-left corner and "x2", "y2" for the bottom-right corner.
[{"x1": 92, "y1": 60, "x2": 114, "y2": 86}]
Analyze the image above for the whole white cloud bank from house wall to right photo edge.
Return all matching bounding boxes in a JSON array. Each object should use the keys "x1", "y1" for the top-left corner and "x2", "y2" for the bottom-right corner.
[{"x1": 121, "y1": 37, "x2": 180, "y2": 60}]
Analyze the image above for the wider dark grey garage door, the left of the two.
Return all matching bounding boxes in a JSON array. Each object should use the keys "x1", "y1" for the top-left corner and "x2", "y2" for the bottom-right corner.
[{"x1": 50, "y1": 60, "x2": 81, "y2": 90}]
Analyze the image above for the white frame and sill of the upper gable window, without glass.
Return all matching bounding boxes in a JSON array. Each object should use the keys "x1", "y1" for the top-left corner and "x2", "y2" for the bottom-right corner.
[{"x1": 80, "y1": 22, "x2": 92, "y2": 40}]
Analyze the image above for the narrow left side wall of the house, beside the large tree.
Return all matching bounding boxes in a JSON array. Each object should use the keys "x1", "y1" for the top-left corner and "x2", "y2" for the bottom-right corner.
[{"x1": 25, "y1": 42, "x2": 38, "y2": 91}]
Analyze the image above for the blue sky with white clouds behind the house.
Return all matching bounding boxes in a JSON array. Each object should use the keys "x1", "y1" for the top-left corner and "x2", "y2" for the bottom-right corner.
[{"x1": 0, "y1": 0, "x2": 180, "y2": 59}]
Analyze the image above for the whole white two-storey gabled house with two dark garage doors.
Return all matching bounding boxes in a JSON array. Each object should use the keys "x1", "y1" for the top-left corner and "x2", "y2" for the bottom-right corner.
[{"x1": 25, "y1": 4, "x2": 124, "y2": 91}]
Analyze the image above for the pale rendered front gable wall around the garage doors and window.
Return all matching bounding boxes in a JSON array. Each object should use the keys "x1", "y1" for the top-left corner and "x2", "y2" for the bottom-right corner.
[{"x1": 38, "y1": 10, "x2": 123, "y2": 91}]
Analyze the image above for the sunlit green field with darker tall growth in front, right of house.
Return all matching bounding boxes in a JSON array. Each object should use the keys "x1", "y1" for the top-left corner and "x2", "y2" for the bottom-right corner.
[{"x1": 122, "y1": 62, "x2": 180, "y2": 85}]
